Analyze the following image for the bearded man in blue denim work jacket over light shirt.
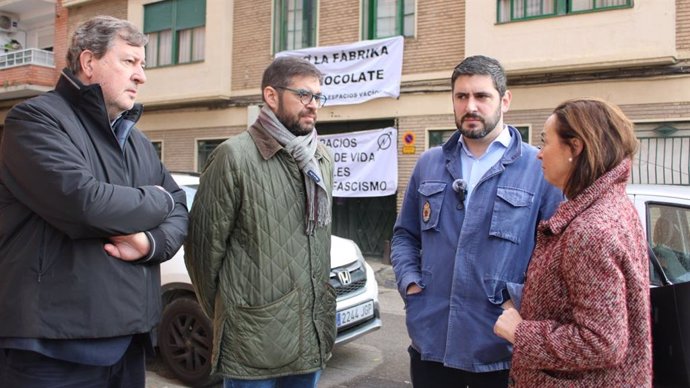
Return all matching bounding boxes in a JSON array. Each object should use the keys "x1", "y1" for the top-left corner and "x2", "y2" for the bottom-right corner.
[{"x1": 391, "y1": 56, "x2": 563, "y2": 388}]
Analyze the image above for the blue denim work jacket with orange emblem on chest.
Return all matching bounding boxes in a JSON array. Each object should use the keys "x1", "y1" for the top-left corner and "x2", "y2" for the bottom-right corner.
[{"x1": 391, "y1": 127, "x2": 563, "y2": 372}]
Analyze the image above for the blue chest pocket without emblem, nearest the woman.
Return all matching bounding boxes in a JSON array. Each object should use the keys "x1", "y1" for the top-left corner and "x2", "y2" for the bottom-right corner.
[{"x1": 489, "y1": 187, "x2": 534, "y2": 244}]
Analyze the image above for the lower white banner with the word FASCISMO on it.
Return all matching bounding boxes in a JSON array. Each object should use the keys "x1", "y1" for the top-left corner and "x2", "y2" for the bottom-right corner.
[{"x1": 319, "y1": 127, "x2": 398, "y2": 197}]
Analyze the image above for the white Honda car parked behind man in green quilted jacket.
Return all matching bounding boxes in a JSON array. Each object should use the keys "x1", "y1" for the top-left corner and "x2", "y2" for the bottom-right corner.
[{"x1": 158, "y1": 173, "x2": 381, "y2": 386}]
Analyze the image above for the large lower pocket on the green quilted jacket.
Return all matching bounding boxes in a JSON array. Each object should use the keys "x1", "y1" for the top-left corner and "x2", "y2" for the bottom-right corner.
[{"x1": 228, "y1": 289, "x2": 302, "y2": 369}]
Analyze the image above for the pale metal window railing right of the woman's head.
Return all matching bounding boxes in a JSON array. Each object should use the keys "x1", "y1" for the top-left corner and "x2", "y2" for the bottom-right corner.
[{"x1": 631, "y1": 136, "x2": 690, "y2": 186}]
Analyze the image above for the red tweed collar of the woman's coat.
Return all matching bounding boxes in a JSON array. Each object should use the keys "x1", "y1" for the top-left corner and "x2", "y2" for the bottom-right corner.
[{"x1": 538, "y1": 159, "x2": 632, "y2": 235}]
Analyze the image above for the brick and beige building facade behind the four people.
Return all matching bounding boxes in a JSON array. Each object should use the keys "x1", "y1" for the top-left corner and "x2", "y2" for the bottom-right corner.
[{"x1": 0, "y1": 0, "x2": 690, "y2": 254}]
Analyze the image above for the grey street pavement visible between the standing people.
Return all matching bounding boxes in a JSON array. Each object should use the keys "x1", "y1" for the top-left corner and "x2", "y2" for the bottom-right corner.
[{"x1": 146, "y1": 259, "x2": 411, "y2": 388}]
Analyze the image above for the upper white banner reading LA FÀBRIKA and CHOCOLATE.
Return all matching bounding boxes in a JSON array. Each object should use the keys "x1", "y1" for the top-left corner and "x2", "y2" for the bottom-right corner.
[{"x1": 276, "y1": 36, "x2": 404, "y2": 106}]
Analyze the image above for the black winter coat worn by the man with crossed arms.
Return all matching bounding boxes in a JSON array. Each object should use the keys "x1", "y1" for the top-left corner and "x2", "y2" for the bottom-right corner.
[{"x1": 0, "y1": 70, "x2": 187, "y2": 339}]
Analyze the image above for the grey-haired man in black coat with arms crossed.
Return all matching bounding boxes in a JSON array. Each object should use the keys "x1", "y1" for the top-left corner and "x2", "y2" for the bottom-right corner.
[{"x1": 0, "y1": 16, "x2": 187, "y2": 388}]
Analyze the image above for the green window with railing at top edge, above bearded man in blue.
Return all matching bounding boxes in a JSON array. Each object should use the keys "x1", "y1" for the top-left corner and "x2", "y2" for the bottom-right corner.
[{"x1": 497, "y1": 0, "x2": 633, "y2": 23}]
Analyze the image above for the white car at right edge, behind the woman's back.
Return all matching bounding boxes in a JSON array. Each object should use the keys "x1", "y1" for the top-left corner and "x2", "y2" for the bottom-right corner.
[{"x1": 627, "y1": 185, "x2": 690, "y2": 388}]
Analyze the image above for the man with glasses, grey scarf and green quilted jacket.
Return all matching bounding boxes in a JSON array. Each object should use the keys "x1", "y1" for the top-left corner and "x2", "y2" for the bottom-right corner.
[{"x1": 185, "y1": 57, "x2": 336, "y2": 388}]
